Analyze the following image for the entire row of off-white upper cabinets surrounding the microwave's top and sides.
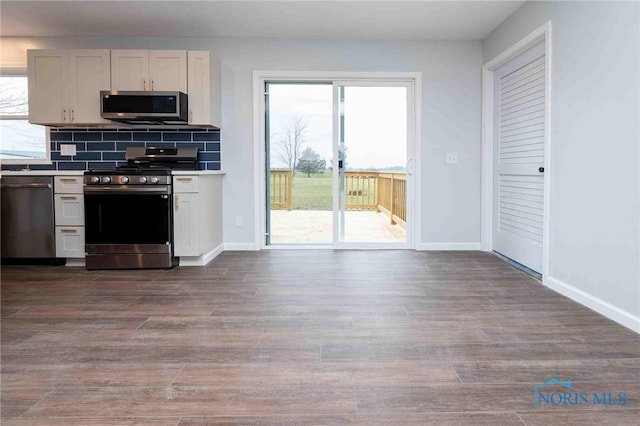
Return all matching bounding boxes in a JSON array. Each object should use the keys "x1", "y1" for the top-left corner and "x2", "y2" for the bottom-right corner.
[{"x1": 27, "y1": 49, "x2": 222, "y2": 129}]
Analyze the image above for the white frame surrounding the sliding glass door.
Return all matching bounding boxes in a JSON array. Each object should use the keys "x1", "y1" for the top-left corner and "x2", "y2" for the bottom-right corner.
[{"x1": 253, "y1": 71, "x2": 422, "y2": 250}]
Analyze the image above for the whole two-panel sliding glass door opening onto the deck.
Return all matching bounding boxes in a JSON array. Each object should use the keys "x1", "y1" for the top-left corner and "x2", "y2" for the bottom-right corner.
[{"x1": 265, "y1": 81, "x2": 410, "y2": 247}]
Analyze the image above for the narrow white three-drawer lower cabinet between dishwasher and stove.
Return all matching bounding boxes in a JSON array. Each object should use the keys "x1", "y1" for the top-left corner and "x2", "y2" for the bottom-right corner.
[{"x1": 54, "y1": 176, "x2": 84, "y2": 258}]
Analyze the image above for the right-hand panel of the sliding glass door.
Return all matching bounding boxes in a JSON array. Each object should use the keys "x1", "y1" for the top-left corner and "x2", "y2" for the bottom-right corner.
[{"x1": 334, "y1": 82, "x2": 408, "y2": 243}]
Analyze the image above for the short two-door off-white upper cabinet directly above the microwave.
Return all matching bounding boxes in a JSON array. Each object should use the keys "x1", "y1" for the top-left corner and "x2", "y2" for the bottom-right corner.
[{"x1": 111, "y1": 50, "x2": 187, "y2": 93}]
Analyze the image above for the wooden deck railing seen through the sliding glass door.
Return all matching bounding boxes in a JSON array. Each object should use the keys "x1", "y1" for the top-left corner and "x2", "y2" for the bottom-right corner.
[{"x1": 270, "y1": 169, "x2": 407, "y2": 227}]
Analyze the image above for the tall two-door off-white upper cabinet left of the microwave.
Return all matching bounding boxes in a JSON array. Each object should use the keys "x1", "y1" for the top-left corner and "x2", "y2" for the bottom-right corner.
[{"x1": 27, "y1": 50, "x2": 111, "y2": 125}]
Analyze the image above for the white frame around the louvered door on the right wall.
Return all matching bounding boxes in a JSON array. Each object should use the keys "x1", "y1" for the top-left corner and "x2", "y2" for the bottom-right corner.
[{"x1": 480, "y1": 21, "x2": 552, "y2": 283}]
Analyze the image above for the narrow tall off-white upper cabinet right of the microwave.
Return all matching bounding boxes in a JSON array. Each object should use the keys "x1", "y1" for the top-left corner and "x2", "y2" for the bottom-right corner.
[{"x1": 187, "y1": 51, "x2": 221, "y2": 128}]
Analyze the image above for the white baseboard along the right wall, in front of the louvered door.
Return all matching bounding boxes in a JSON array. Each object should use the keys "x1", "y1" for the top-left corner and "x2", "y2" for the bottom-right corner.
[{"x1": 543, "y1": 276, "x2": 640, "y2": 333}]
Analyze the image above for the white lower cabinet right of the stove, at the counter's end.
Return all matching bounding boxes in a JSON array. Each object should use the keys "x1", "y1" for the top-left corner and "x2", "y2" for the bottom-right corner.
[{"x1": 173, "y1": 175, "x2": 222, "y2": 265}]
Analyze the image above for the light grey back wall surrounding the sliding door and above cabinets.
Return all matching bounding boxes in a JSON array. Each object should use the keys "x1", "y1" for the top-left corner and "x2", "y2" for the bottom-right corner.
[{"x1": 0, "y1": 37, "x2": 482, "y2": 247}]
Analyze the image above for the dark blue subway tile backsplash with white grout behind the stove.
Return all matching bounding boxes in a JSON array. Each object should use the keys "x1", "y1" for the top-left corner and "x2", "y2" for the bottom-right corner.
[{"x1": 2, "y1": 128, "x2": 221, "y2": 170}]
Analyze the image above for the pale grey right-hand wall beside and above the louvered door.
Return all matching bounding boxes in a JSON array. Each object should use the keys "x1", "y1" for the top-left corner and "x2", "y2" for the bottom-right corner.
[{"x1": 483, "y1": 2, "x2": 640, "y2": 326}]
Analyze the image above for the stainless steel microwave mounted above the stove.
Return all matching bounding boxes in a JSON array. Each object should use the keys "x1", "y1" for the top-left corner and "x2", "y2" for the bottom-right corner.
[{"x1": 100, "y1": 90, "x2": 189, "y2": 124}]
